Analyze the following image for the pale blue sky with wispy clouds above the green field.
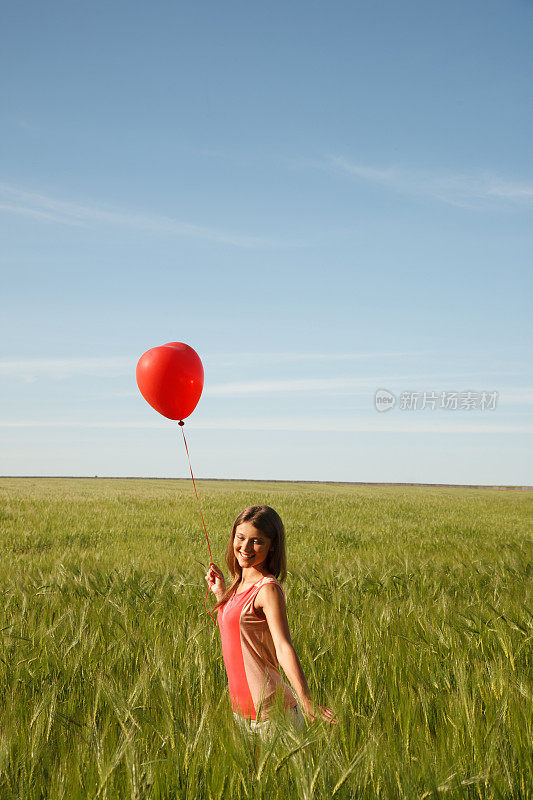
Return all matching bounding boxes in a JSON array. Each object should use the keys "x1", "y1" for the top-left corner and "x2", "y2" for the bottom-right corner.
[{"x1": 0, "y1": 0, "x2": 533, "y2": 484}]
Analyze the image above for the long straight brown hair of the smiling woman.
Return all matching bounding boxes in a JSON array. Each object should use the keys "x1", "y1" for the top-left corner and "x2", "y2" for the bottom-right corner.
[{"x1": 213, "y1": 506, "x2": 287, "y2": 611}]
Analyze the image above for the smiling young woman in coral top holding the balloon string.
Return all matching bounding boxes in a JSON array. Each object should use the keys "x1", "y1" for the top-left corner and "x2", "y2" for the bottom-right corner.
[{"x1": 205, "y1": 506, "x2": 337, "y2": 728}]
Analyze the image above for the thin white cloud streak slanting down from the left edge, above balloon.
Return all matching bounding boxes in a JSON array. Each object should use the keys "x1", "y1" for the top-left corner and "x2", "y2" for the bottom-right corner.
[{"x1": 0, "y1": 183, "x2": 303, "y2": 248}]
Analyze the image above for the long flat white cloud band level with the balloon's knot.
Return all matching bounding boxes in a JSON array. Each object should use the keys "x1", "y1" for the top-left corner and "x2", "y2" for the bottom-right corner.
[{"x1": 0, "y1": 412, "x2": 533, "y2": 434}]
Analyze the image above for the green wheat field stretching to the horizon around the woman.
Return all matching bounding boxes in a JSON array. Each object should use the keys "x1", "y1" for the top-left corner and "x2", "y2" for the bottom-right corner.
[{"x1": 0, "y1": 478, "x2": 533, "y2": 800}]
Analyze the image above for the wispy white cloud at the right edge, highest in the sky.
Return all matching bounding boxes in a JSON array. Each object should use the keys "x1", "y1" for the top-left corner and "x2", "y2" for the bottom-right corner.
[{"x1": 327, "y1": 156, "x2": 533, "y2": 208}]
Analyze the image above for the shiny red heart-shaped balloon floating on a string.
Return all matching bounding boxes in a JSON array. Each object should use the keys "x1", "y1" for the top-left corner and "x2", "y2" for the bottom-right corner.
[{"x1": 136, "y1": 342, "x2": 204, "y2": 420}]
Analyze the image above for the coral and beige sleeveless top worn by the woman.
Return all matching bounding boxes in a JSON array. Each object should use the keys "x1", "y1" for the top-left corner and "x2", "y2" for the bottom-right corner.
[{"x1": 218, "y1": 575, "x2": 296, "y2": 720}]
